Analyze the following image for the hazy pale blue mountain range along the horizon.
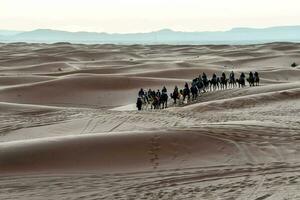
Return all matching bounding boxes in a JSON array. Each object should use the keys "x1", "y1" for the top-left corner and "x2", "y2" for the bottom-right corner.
[{"x1": 0, "y1": 26, "x2": 300, "y2": 44}]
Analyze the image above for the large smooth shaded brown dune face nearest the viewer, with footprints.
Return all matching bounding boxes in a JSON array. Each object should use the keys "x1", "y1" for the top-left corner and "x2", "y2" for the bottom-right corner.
[{"x1": 0, "y1": 130, "x2": 238, "y2": 173}]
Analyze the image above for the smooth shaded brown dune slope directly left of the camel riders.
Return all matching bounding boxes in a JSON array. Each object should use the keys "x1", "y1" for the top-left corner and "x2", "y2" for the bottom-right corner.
[{"x1": 0, "y1": 74, "x2": 183, "y2": 107}]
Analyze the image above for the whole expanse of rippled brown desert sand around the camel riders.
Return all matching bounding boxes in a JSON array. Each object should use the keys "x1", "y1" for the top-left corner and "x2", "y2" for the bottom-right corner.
[{"x1": 0, "y1": 43, "x2": 300, "y2": 200}]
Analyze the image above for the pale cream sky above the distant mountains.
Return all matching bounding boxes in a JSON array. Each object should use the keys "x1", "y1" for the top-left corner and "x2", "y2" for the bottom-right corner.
[{"x1": 0, "y1": 0, "x2": 300, "y2": 33}]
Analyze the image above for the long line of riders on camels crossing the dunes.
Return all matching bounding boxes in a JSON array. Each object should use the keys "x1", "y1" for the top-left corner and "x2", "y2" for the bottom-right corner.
[{"x1": 136, "y1": 71, "x2": 259, "y2": 110}]
